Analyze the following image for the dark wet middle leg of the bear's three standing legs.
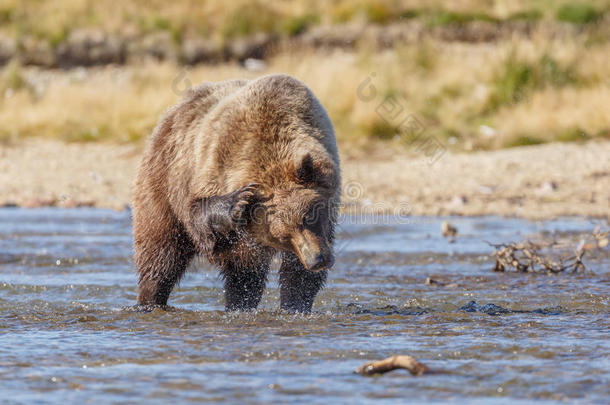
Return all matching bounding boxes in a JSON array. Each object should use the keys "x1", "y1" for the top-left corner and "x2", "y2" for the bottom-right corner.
[{"x1": 222, "y1": 261, "x2": 269, "y2": 311}]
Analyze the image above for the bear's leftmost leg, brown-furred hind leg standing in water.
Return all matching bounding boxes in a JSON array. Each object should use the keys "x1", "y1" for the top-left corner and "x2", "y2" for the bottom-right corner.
[{"x1": 134, "y1": 218, "x2": 195, "y2": 305}]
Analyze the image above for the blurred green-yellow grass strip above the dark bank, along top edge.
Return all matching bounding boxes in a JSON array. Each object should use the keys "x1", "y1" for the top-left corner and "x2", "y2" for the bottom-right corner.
[{"x1": 0, "y1": 0, "x2": 610, "y2": 46}]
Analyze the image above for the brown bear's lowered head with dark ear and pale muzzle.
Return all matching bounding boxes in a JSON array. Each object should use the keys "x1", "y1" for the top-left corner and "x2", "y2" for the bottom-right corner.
[{"x1": 252, "y1": 153, "x2": 340, "y2": 271}]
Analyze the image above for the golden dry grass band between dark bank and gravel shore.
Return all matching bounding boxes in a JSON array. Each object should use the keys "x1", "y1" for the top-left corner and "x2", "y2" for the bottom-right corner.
[{"x1": 0, "y1": 24, "x2": 610, "y2": 150}]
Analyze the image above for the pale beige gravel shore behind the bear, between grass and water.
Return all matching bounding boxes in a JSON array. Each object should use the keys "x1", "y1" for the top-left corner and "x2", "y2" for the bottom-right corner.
[{"x1": 0, "y1": 139, "x2": 610, "y2": 219}]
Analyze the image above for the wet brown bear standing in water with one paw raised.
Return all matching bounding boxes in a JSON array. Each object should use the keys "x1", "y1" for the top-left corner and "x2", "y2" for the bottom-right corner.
[{"x1": 133, "y1": 74, "x2": 341, "y2": 312}]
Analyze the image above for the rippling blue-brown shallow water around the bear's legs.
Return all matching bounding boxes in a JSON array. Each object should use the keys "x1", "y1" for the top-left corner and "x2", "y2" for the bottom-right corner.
[{"x1": 0, "y1": 209, "x2": 610, "y2": 404}]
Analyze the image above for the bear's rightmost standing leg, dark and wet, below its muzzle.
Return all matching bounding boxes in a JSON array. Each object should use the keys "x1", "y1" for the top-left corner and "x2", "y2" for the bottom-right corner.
[{"x1": 280, "y1": 252, "x2": 327, "y2": 313}]
